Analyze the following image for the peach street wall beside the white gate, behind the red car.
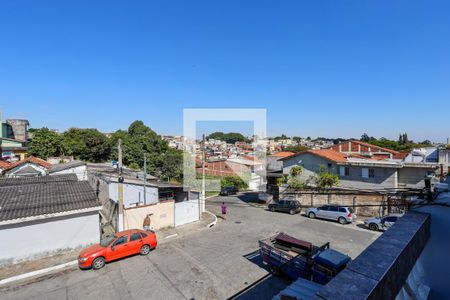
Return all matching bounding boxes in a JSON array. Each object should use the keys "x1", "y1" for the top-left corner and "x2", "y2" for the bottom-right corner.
[{"x1": 123, "y1": 200, "x2": 174, "y2": 230}]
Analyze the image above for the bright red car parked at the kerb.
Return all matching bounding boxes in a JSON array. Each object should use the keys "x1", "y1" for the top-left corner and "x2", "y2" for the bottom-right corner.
[{"x1": 78, "y1": 229, "x2": 157, "y2": 270}]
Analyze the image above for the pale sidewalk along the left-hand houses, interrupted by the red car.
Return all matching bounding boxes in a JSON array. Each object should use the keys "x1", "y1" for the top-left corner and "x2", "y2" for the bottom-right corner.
[{"x1": 0, "y1": 213, "x2": 215, "y2": 280}]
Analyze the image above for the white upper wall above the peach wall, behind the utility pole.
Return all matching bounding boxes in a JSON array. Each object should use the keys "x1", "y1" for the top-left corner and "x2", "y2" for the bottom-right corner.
[{"x1": 109, "y1": 182, "x2": 159, "y2": 207}]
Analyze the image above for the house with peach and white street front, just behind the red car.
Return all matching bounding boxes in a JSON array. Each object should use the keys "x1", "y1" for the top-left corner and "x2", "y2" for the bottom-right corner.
[{"x1": 88, "y1": 164, "x2": 200, "y2": 231}]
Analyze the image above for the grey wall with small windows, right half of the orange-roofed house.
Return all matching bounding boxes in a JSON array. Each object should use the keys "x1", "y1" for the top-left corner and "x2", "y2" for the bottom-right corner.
[{"x1": 339, "y1": 166, "x2": 397, "y2": 190}]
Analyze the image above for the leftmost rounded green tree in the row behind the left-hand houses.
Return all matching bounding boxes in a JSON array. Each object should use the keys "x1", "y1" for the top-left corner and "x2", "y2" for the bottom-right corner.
[{"x1": 28, "y1": 127, "x2": 63, "y2": 159}]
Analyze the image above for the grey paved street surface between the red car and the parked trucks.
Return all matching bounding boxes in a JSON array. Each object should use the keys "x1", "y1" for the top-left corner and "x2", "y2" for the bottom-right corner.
[{"x1": 0, "y1": 197, "x2": 379, "y2": 299}]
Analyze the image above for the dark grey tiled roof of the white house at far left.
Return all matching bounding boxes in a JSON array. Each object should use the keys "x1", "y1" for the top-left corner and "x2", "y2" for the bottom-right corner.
[{"x1": 0, "y1": 181, "x2": 100, "y2": 221}]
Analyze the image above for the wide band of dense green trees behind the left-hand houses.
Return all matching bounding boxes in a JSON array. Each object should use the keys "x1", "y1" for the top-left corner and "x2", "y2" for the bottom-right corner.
[{"x1": 28, "y1": 121, "x2": 183, "y2": 181}]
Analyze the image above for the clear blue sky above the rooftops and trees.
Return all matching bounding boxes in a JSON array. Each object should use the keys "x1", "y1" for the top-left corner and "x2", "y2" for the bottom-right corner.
[{"x1": 0, "y1": 0, "x2": 450, "y2": 141}]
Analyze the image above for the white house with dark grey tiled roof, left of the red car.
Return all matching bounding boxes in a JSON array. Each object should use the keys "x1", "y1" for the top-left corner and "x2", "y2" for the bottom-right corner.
[{"x1": 0, "y1": 174, "x2": 101, "y2": 265}]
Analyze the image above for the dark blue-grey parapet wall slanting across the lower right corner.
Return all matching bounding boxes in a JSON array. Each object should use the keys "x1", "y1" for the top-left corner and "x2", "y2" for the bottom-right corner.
[{"x1": 314, "y1": 212, "x2": 430, "y2": 300}]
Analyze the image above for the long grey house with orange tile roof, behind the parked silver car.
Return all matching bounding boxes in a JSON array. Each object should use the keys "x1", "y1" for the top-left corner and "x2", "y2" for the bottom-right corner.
[{"x1": 281, "y1": 148, "x2": 438, "y2": 190}]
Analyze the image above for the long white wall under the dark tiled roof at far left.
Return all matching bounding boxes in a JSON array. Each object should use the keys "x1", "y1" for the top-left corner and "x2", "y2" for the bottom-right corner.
[{"x1": 0, "y1": 212, "x2": 100, "y2": 265}]
